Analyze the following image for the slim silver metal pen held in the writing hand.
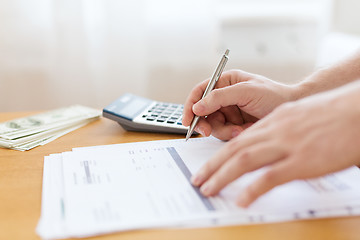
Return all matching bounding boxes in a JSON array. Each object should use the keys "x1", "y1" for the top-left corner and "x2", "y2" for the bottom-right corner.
[{"x1": 185, "y1": 49, "x2": 230, "y2": 141}]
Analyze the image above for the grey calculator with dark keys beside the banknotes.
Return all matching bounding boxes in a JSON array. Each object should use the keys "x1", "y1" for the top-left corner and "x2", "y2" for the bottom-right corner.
[{"x1": 103, "y1": 93, "x2": 196, "y2": 134}]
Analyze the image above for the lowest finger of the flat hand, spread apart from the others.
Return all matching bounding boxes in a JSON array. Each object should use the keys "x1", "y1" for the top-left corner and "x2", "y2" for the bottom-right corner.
[{"x1": 237, "y1": 159, "x2": 298, "y2": 207}]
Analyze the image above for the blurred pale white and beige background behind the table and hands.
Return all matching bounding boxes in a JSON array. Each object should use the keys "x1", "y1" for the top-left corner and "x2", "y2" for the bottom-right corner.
[{"x1": 0, "y1": 0, "x2": 360, "y2": 112}]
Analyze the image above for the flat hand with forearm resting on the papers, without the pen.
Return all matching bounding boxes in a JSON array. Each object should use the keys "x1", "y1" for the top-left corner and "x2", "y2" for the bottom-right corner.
[{"x1": 192, "y1": 80, "x2": 360, "y2": 207}]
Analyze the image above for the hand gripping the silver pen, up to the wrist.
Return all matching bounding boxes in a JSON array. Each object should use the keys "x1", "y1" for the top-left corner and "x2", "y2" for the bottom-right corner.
[{"x1": 182, "y1": 70, "x2": 297, "y2": 140}]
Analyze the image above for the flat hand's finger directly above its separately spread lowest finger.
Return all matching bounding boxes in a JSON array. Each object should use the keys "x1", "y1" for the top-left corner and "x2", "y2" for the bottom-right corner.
[{"x1": 200, "y1": 143, "x2": 286, "y2": 196}]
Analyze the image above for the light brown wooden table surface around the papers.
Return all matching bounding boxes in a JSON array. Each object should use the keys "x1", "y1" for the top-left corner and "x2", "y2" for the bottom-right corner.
[{"x1": 0, "y1": 112, "x2": 360, "y2": 240}]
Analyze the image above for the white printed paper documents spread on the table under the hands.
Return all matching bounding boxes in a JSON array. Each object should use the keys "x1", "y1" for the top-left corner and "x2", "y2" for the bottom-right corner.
[{"x1": 37, "y1": 138, "x2": 360, "y2": 239}]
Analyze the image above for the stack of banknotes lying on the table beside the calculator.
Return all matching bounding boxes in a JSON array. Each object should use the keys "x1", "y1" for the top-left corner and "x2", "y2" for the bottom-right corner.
[{"x1": 0, "y1": 105, "x2": 101, "y2": 151}]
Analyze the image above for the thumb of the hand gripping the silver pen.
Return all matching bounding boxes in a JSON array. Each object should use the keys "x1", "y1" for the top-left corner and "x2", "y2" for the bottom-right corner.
[{"x1": 193, "y1": 83, "x2": 249, "y2": 116}]
